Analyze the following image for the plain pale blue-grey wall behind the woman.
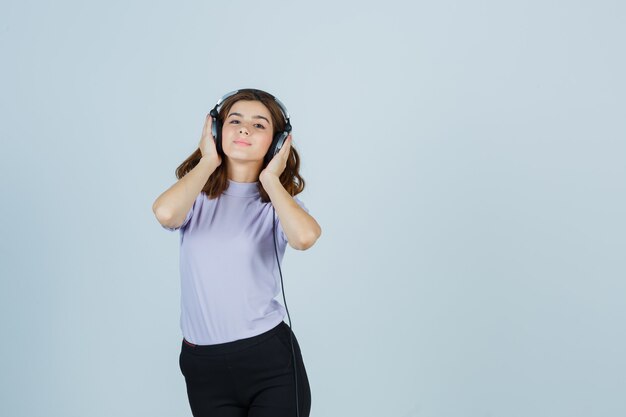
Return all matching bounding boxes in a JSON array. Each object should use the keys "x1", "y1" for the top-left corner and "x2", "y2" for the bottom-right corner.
[{"x1": 0, "y1": 0, "x2": 626, "y2": 417}]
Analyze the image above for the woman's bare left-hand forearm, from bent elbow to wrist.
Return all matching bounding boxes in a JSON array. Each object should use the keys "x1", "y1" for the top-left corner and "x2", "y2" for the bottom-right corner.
[{"x1": 152, "y1": 156, "x2": 219, "y2": 227}]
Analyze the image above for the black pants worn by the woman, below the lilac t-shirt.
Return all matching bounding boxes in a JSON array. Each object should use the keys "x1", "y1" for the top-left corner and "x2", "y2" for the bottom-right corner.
[{"x1": 179, "y1": 321, "x2": 311, "y2": 417}]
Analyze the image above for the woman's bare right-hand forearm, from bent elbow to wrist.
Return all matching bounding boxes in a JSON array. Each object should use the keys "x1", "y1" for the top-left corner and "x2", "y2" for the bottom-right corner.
[{"x1": 259, "y1": 173, "x2": 322, "y2": 250}]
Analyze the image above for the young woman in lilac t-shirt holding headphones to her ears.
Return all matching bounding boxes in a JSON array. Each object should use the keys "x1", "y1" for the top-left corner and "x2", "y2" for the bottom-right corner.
[{"x1": 152, "y1": 89, "x2": 321, "y2": 417}]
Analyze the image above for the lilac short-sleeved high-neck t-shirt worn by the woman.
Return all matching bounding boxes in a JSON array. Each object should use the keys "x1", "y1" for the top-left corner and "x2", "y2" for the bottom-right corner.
[{"x1": 163, "y1": 180, "x2": 309, "y2": 345}]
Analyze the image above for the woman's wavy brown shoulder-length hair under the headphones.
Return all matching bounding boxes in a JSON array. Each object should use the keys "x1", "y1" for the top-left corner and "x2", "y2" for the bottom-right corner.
[{"x1": 176, "y1": 89, "x2": 304, "y2": 202}]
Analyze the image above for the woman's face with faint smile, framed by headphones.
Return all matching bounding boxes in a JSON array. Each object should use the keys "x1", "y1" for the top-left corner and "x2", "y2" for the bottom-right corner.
[{"x1": 222, "y1": 100, "x2": 274, "y2": 161}]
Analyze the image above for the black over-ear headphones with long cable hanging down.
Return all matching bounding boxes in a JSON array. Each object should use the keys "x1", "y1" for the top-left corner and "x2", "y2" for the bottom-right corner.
[{"x1": 210, "y1": 88, "x2": 300, "y2": 417}]
